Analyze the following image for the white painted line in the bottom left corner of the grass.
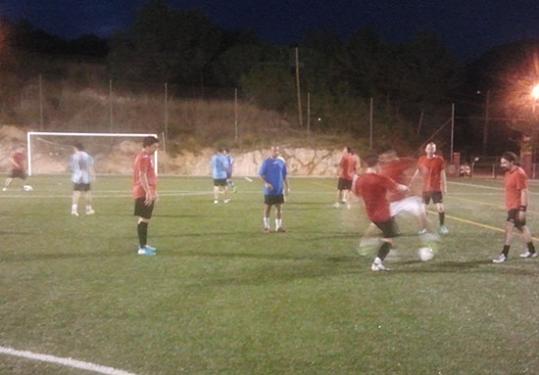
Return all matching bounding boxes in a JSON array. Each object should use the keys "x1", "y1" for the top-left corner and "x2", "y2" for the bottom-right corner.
[{"x1": 0, "y1": 346, "x2": 135, "y2": 375}]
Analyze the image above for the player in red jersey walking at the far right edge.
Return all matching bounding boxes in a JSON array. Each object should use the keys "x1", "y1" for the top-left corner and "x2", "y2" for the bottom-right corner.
[{"x1": 492, "y1": 152, "x2": 537, "y2": 263}]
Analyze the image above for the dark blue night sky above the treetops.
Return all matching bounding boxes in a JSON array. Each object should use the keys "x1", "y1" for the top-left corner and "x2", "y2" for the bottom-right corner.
[{"x1": 0, "y1": 0, "x2": 539, "y2": 58}]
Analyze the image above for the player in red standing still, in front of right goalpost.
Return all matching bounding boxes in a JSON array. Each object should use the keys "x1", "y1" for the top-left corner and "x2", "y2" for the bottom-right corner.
[{"x1": 133, "y1": 136, "x2": 159, "y2": 255}]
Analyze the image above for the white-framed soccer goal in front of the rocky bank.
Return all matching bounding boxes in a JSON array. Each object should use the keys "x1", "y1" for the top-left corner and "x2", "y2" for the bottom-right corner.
[{"x1": 26, "y1": 132, "x2": 158, "y2": 176}]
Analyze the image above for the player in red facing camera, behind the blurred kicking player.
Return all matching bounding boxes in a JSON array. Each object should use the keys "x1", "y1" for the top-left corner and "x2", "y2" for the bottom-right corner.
[{"x1": 410, "y1": 142, "x2": 449, "y2": 234}]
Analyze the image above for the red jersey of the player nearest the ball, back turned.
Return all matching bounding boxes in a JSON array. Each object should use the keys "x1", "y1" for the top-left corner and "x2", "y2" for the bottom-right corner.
[{"x1": 352, "y1": 173, "x2": 397, "y2": 223}]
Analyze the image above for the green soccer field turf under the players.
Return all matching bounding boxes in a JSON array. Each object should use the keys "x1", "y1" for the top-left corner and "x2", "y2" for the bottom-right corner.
[{"x1": 0, "y1": 177, "x2": 539, "y2": 374}]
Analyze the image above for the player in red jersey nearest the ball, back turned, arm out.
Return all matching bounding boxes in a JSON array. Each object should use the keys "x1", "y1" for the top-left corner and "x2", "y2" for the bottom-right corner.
[{"x1": 352, "y1": 155, "x2": 408, "y2": 271}]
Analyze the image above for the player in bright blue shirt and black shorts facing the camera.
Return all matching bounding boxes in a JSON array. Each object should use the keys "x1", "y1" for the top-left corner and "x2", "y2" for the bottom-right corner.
[{"x1": 259, "y1": 146, "x2": 289, "y2": 233}]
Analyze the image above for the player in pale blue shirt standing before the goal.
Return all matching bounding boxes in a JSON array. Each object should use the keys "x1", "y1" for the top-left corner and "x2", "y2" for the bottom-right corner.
[{"x1": 70, "y1": 143, "x2": 95, "y2": 216}]
